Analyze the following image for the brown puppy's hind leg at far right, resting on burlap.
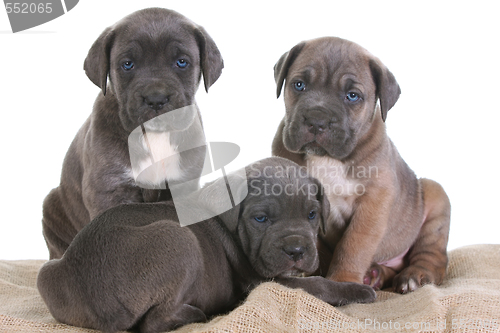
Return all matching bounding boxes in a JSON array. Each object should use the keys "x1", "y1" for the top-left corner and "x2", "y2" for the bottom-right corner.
[{"x1": 393, "y1": 179, "x2": 451, "y2": 294}]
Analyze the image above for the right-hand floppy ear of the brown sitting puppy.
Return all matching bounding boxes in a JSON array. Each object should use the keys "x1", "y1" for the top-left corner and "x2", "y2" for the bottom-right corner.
[{"x1": 370, "y1": 58, "x2": 401, "y2": 122}]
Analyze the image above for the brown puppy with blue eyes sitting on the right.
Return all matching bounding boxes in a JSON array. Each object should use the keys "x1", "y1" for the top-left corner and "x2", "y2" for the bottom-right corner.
[{"x1": 272, "y1": 37, "x2": 450, "y2": 293}]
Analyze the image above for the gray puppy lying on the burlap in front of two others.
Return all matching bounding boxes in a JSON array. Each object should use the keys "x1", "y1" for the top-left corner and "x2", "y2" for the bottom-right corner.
[{"x1": 37, "y1": 157, "x2": 375, "y2": 332}]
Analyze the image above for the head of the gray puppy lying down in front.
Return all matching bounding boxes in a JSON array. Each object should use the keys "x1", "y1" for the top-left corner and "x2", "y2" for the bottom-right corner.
[{"x1": 215, "y1": 157, "x2": 329, "y2": 278}]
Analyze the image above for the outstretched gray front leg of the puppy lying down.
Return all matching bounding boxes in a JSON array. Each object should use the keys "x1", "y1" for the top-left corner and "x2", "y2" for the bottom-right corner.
[{"x1": 275, "y1": 276, "x2": 377, "y2": 306}]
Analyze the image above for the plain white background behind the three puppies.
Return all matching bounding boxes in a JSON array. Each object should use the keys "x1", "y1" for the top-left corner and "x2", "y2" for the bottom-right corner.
[{"x1": 0, "y1": 0, "x2": 500, "y2": 259}]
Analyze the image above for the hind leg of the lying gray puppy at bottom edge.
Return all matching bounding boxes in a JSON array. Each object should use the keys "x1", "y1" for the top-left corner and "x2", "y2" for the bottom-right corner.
[{"x1": 139, "y1": 303, "x2": 207, "y2": 333}]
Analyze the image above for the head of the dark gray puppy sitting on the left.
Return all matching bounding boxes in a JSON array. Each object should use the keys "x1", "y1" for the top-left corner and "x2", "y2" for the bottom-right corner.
[{"x1": 84, "y1": 8, "x2": 223, "y2": 131}]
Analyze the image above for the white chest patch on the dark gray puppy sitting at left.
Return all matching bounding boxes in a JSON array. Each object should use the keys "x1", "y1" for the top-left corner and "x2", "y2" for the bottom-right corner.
[{"x1": 133, "y1": 132, "x2": 184, "y2": 188}]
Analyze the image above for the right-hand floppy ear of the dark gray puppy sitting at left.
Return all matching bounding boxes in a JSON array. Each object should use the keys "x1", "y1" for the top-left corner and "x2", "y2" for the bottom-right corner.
[{"x1": 194, "y1": 26, "x2": 224, "y2": 92}]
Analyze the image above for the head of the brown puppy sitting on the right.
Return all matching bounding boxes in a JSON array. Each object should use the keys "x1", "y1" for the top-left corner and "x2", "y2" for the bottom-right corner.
[{"x1": 274, "y1": 37, "x2": 401, "y2": 160}]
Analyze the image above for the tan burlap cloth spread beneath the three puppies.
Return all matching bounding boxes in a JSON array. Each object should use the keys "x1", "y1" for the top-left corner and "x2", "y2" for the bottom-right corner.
[{"x1": 0, "y1": 245, "x2": 500, "y2": 333}]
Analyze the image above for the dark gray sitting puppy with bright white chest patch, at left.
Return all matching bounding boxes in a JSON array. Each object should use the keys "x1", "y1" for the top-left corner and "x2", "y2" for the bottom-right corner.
[{"x1": 43, "y1": 8, "x2": 223, "y2": 258}]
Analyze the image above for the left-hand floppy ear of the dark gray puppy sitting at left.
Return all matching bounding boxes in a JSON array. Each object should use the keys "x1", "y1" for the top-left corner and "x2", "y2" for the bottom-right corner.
[{"x1": 83, "y1": 27, "x2": 115, "y2": 95}]
